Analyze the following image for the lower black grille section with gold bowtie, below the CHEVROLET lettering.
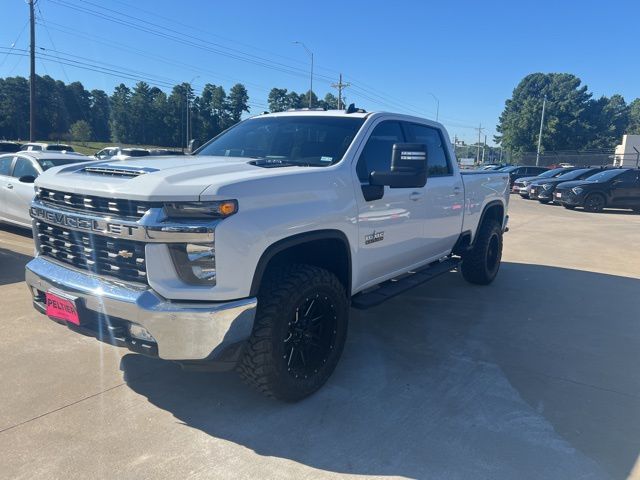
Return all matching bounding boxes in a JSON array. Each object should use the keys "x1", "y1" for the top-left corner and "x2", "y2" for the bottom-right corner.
[{"x1": 36, "y1": 221, "x2": 147, "y2": 283}]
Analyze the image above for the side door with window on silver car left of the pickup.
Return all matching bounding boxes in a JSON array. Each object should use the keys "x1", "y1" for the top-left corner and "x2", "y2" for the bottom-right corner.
[{"x1": 5, "y1": 157, "x2": 40, "y2": 227}]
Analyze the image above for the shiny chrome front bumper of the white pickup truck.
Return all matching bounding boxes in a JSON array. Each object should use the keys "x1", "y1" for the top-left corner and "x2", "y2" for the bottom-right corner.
[{"x1": 26, "y1": 257, "x2": 257, "y2": 360}]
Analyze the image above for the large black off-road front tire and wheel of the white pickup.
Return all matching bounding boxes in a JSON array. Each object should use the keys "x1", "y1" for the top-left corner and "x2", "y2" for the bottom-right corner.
[{"x1": 237, "y1": 264, "x2": 349, "y2": 402}]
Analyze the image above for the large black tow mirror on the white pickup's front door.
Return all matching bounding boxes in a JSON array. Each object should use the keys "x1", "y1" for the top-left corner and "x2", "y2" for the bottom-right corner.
[{"x1": 369, "y1": 143, "x2": 428, "y2": 188}]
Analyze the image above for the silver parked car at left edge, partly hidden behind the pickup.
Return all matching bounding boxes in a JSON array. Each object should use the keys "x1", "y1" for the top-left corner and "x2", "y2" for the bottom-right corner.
[{"x1": 0, "y1": 151, "x2": 95, "y2": 228}]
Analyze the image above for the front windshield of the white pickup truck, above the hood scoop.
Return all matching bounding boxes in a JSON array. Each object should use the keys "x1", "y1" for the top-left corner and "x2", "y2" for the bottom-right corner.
[{"x1": 195, "y1": 116, "x2": 364, "y2": 167}]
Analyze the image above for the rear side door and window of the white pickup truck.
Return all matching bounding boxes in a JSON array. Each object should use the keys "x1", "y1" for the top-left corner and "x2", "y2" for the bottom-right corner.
[{"x1": 403, "y1": 122, "x2": 464, "y2": 259}]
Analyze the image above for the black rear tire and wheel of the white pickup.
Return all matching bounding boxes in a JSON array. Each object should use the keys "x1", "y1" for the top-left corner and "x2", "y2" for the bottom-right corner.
[{"x1": 460, "y1": 220, "x2": 502, "y2": 285}]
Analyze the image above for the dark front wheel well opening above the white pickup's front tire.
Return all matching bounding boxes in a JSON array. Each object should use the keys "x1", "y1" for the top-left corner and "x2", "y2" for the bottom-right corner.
[{"x1": 251, "y1": 230, "x2": 351, "y2": 296}]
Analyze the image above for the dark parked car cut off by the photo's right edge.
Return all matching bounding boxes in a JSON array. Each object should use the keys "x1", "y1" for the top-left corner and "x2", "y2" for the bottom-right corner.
[{"x1": 553, "y1": 168, "x2": 640, "y2": 212}]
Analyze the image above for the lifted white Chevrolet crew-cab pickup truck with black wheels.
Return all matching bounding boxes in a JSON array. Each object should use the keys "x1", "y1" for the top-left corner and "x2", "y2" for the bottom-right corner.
[{"x1": 26, "y1": 106, "x2": 509, "y2": 401}]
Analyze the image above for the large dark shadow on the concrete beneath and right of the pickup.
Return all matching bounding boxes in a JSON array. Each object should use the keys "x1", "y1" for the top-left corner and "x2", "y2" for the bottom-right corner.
[{"x1": 121, "y1": 263, "x2": 640, "y2": 478}]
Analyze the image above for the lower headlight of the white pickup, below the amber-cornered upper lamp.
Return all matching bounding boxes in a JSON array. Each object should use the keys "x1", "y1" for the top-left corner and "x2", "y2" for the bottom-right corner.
[{"x1": 169, "y1": 243, "x2": 216, "y2": 286}]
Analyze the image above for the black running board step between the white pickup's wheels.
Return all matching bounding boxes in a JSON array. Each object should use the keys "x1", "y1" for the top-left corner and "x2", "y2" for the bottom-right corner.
[{"x1": 351, "y1": 258, "x2": 460, "y2": 310}]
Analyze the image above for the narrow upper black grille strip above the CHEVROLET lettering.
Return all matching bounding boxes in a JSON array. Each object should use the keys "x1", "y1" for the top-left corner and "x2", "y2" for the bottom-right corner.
[{"x1": 36, "y1": 188, "x2": 162, "y2": 218}]
